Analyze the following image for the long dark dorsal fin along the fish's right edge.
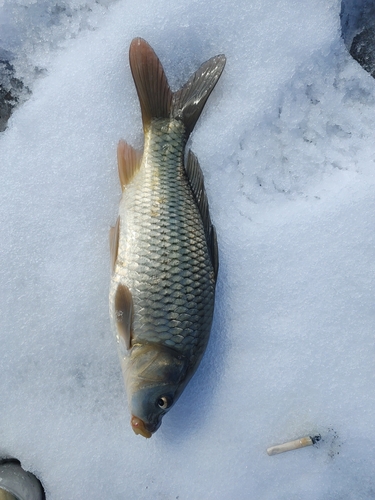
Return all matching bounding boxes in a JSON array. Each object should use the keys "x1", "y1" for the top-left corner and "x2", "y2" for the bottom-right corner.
[{"x1": 185, "y1": 149, "x2": 219, "y2": 280}]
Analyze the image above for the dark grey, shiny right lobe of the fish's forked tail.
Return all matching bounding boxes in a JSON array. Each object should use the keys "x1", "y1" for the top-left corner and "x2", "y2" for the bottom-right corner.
[{"x1": 172, "y1": 54, "x2": 226, "y2": 135}]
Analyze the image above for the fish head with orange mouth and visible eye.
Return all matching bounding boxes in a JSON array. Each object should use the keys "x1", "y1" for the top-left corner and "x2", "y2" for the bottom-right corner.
[{"x1": 125, "y1": 344, "x2": 187, "y2": 438}]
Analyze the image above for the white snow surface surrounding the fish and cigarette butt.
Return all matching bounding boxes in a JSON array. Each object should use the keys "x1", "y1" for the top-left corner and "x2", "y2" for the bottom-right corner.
[{"x1": 0, "y1": 0, "x2": 375, "y2": 500}]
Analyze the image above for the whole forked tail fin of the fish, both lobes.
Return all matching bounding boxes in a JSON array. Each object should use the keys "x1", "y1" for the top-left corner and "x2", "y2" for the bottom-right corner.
[{"x1": 129, "y1": 38, "x2": 226, "y2": 136}]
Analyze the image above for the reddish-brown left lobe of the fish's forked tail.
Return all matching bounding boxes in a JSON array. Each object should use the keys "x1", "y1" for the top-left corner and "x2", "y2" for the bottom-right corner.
[{"x1": 129, "y1": 38, "x2": 172, "y2": 130}]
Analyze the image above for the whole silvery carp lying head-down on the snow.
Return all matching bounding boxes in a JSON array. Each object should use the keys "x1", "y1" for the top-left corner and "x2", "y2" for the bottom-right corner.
[{"x1": 109, "y1": 38, "x2": 226, "y2": 438}]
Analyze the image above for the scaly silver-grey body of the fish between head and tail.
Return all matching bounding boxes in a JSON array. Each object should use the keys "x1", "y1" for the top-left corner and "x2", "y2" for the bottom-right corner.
[{"x1": 117, "y1": 120, "x2": 215, "y2": 357}]
